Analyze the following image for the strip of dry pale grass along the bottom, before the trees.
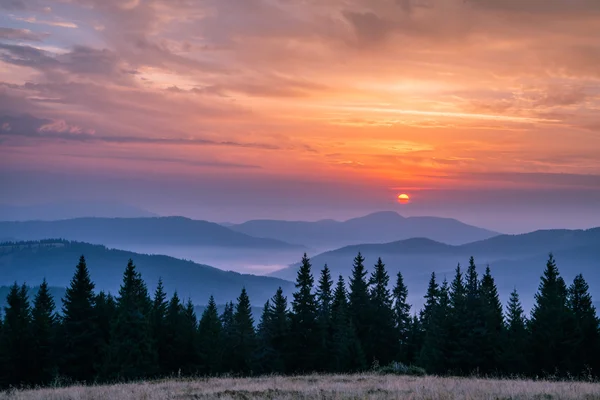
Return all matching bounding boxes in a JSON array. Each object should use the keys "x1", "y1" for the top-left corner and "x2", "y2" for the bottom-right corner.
[{"x1": 0, "y1": 374, "x2": 600, "y2": 400}]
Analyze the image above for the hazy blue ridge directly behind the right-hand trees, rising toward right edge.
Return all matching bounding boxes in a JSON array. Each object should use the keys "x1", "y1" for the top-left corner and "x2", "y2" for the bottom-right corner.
[{"x1": 271, "y1": 228, "x2": 600, "y2": 307}]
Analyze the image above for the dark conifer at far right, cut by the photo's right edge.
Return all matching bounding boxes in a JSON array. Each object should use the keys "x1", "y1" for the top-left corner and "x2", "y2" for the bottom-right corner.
[{"x1": 568, "y1": 274, "x2": 600, "y2": 376}]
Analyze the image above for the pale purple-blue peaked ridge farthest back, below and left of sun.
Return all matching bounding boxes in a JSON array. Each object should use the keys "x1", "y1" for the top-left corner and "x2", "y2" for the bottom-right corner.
[{"x1": 229, "y1": 211, "x2": 499, "y2": 249}]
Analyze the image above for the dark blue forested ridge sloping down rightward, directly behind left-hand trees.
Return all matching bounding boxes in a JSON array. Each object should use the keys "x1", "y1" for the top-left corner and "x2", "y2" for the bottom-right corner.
[{"x1": 0, "y1": 240, "x2": 293, "y2": 306}]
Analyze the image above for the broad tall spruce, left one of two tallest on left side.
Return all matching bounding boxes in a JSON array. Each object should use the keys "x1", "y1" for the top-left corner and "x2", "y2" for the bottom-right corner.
[{"x1": 60, "y1": 256, "x2": 101, "y2": 382}]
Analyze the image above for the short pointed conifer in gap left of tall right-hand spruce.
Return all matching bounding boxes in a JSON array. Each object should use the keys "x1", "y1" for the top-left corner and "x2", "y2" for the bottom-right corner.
[{"x1": 500, "y1": 289, "x2": 529, "y2": 375}]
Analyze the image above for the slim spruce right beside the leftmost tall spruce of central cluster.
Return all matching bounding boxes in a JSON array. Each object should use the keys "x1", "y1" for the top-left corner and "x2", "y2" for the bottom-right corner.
[{"x1": 316, "y1": 264, "x2": 333, "y2": 370}]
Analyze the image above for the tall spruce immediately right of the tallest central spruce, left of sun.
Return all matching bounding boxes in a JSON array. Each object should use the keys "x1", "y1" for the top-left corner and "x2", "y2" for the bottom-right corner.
[{"x1": 369, "y1": 258, "x2": 399, "y2": 365}]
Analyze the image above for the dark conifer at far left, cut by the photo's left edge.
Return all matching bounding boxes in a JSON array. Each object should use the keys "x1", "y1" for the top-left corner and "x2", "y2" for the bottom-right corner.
[{"x1": 0, "y1": 282, "x2": 35, "y2": 386}]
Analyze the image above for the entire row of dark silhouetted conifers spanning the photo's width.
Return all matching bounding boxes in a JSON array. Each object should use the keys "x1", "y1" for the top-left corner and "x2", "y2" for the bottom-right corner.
[{"x1": 0, "y1": 253, "x2": 600, "y2": 388}]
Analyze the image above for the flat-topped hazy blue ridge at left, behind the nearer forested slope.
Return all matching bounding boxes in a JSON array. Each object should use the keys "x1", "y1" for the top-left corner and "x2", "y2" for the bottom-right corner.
[{"x1": 0, "y1": 217, "x2": 298, "y2": 249}]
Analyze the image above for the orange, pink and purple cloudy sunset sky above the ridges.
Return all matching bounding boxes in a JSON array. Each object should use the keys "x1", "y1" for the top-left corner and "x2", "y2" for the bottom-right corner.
[{"x1": 0, "y1": 0, "x2": 600, "y2": 232}]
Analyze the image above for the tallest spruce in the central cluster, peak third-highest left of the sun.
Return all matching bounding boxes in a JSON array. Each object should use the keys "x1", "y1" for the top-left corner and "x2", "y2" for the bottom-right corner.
[{"x1": 348, "y1": 252, "x2": 374, "y2": 364}]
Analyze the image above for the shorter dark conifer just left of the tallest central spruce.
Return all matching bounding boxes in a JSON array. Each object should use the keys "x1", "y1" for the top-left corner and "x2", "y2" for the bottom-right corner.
[{"x1": 329, "y1": 275, "x2": 366, "y2": 372}]
